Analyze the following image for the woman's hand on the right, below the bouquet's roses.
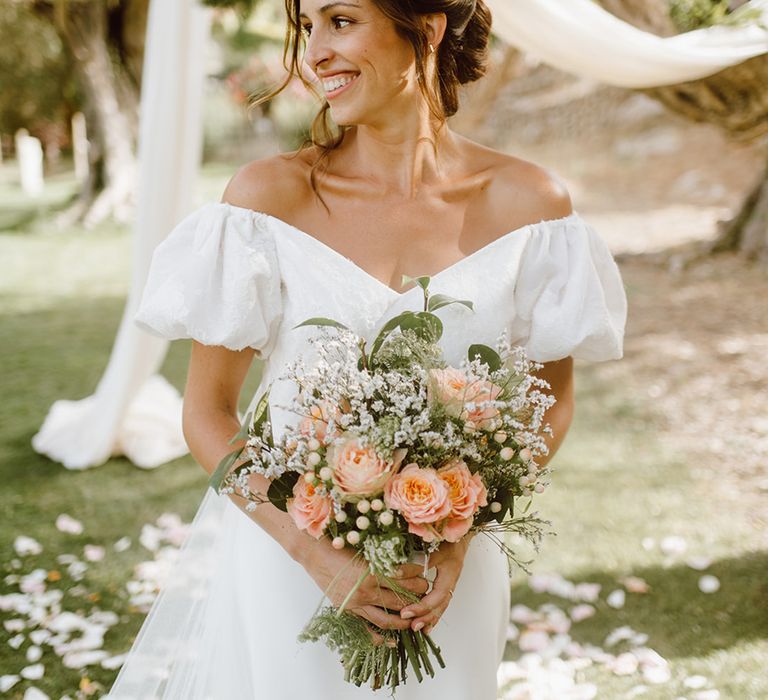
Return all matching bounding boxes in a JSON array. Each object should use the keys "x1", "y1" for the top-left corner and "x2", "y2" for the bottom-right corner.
[{"x1": 400, "y1": 532, "x2": 474, "y2": 634}]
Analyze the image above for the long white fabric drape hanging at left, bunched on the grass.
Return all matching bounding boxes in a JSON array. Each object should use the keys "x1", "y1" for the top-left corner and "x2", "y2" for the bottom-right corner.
[{"x1": 32, "y1": 0, "x2": 210, "y2": 469}]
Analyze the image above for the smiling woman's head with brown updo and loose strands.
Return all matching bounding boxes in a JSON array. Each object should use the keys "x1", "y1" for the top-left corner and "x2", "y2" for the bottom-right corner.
[{"x1": 253, "y1": 0, "x2": 492, "y2": 209}]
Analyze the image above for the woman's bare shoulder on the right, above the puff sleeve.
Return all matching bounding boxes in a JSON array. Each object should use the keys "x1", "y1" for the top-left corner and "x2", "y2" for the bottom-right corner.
[{"x1": 464, "y1": 142, "x2": 573, "y2": 230}]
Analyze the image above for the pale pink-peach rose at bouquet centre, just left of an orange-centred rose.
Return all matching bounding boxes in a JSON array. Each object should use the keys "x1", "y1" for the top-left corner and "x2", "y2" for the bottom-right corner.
[{"x1": 326, "y1": 437, "x2": 406, "y2": 500}]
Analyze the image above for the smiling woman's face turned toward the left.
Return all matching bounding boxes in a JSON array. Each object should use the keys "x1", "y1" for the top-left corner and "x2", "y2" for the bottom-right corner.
[{"x1": 299, "y1": 0, "x2": 421, "y2": 126}]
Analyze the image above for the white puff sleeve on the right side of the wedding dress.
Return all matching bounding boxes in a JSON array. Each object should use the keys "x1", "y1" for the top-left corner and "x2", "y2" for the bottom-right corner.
[{"x1": 510, "y1": 212, "x2": 627, "y2": 362}]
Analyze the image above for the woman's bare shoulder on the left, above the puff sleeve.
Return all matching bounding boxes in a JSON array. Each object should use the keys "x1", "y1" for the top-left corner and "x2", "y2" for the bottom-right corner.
[{"x1": 221, "y1": 151, "x2": 316, "y2": 218}]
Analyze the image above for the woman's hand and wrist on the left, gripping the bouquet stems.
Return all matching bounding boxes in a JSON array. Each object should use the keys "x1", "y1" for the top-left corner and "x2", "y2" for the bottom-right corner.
[{"x1": 298, "y1": 538, "x2": 429, "y2": 644}]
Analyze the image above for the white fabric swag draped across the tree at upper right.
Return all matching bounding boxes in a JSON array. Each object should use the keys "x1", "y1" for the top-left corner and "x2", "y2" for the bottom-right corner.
[{"x1": 486, "y1": 0, "x2": 768, "y2": 88}]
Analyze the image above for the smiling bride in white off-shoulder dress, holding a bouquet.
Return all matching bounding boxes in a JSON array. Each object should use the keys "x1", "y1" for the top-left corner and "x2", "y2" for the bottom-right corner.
[{"x1": 109, "y1": 0, "x2": 626, "y2": 700}]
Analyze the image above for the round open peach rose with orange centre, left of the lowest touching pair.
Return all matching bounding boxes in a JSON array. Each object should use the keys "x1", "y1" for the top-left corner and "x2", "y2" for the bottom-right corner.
[{"x1": 384, "y1": 462, "x2": 451, "y2": 542}]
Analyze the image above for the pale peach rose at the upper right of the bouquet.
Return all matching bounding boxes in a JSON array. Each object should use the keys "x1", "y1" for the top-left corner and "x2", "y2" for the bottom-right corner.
[{"x1": 427, "y1": 367, "x2": 501, "y2": 430}]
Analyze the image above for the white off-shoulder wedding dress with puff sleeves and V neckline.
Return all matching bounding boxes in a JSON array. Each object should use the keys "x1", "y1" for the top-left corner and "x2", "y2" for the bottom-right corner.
[{"x1": 108, "y1": 203, "x2": 626, "y2": 700}]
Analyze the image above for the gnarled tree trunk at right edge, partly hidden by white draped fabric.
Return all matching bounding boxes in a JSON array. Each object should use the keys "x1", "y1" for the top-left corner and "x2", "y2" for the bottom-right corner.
[{"x1": 599, "y1": 0, "x2": 768, "y2": 262}]
